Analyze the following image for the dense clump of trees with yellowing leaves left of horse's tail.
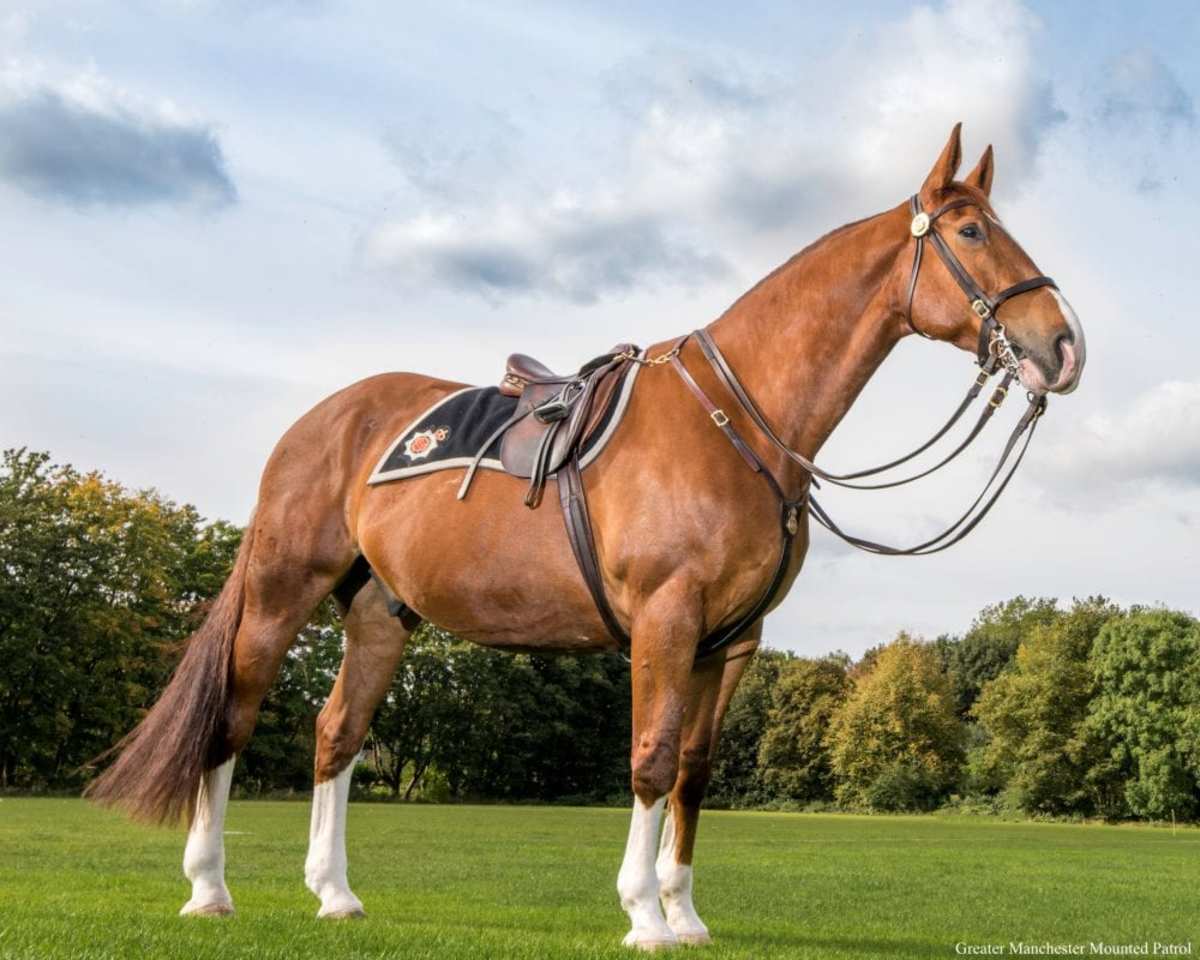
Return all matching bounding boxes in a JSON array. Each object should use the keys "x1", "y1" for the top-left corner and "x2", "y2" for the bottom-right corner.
[{"x1": 0, "y1": 450, "x2": 240, "y2": 787}]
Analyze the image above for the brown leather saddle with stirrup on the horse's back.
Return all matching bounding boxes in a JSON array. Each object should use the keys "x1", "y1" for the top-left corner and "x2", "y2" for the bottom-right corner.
[{"x1": 458, "y1": 343, "x2": 637, "y2": 508}]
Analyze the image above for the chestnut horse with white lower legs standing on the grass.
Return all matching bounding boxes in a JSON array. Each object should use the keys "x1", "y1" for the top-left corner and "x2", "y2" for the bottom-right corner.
[{"x1": 90, "y1": 126, "x2": 1084, "y2": 948}]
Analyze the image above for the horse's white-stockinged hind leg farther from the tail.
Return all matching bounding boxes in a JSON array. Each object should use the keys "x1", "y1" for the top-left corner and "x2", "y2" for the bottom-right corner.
[{"x1": 304, "y1": 580, "x2": 409, "y2": 918}]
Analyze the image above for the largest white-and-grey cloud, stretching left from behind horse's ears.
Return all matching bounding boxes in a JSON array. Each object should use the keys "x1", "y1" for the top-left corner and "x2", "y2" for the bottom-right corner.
[{"x1": 364, "y1": 0, "x2": 1062, "y2": 302}]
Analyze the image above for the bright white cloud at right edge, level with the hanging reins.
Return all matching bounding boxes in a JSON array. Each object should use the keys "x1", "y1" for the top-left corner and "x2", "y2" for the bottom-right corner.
[{"x1": 1038, "y1": 380, "x2": 1200, "y2": 506}]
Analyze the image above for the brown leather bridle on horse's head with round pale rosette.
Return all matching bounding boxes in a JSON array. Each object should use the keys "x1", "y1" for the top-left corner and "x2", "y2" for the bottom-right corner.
[{"x1": 906, "y1": 193, "x2": 1058, "y2": 377}]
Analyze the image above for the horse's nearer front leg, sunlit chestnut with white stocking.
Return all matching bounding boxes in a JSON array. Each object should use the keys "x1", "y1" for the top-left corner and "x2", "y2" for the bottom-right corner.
[{"x1": 617, "y1": 586, "x2": 701, "y2": 950}]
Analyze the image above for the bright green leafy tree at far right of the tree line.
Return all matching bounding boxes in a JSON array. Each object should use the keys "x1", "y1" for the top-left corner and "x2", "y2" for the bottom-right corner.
[{"x1": 1087, "y1": 610, "x2": 1200, "y2": 820}]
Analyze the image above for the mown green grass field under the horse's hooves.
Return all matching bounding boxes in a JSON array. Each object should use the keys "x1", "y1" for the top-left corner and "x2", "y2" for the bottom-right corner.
[{"x1": 0, "y1": 798, "x2": 1200, "y2": 960}]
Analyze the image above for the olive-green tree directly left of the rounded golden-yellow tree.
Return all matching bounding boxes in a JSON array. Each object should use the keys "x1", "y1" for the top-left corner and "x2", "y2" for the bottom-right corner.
[{"x1": 758, "y1": 656, "x2": 850, "y2": 802}]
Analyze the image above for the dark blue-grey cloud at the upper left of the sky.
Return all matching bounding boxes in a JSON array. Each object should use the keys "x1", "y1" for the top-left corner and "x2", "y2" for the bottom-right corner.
[{"x1": 0, "y1": 66, "x2": 238, "y2": 208}]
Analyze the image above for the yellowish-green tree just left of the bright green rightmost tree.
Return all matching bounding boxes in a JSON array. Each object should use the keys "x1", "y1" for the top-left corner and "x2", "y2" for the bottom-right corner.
[{"x1": 970, "y1": 598, "x2": 1120, "y2": 815}]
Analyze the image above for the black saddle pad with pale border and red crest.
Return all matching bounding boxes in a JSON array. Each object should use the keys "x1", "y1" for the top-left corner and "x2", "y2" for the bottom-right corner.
[{"x1": 367, "y1": 364, "x2": 641, "y2": 485}]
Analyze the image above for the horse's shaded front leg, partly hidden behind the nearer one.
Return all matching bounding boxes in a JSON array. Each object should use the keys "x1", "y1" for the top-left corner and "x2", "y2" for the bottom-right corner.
[{"x1": 655, "y1": 622, "x2": 762, "y2": 944}]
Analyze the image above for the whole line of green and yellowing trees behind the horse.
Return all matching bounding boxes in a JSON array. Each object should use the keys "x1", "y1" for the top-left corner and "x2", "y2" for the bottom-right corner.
[{"x1": 0, "y1": 449, "x2": 1200, "y2": 820}]
